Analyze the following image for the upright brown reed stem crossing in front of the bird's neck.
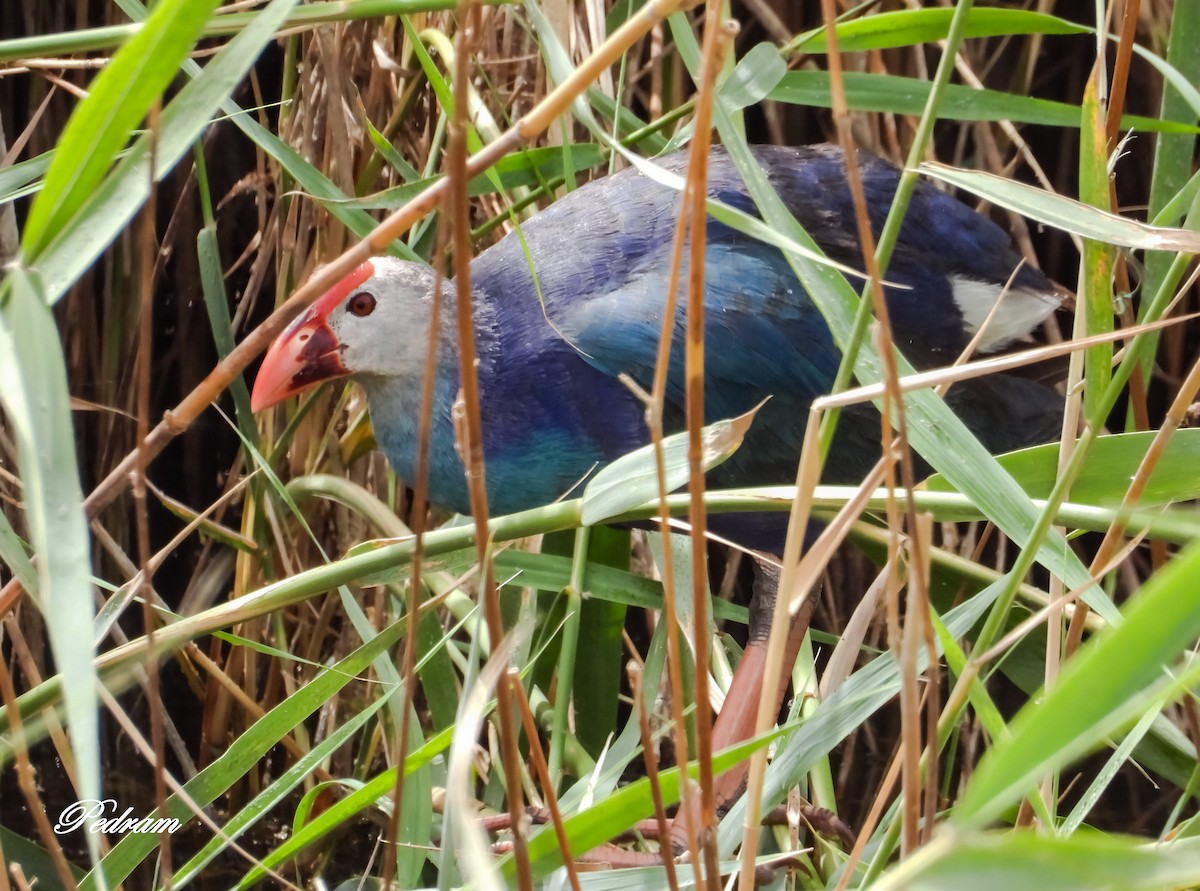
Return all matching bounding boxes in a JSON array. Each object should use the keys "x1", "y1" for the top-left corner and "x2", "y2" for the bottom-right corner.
[{"x1": 443, "y1": 0, "x2": 533, "y2": 891}]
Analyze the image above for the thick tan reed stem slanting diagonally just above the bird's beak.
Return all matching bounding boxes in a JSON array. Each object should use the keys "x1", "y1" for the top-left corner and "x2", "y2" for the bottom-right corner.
[{"x1": 0, "y1": 0, "x2": 698, "y2": 614}]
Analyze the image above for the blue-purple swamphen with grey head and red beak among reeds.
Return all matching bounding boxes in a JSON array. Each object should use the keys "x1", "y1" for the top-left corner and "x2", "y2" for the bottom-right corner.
[{"x1": 253, "y1": 145, "x2": 1062, "y2": 859}]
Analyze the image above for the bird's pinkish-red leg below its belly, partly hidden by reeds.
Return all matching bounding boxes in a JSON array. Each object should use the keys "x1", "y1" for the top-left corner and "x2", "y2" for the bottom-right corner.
[{"x1": 671, "y1": 558, "x2": 816, "y2": 851}]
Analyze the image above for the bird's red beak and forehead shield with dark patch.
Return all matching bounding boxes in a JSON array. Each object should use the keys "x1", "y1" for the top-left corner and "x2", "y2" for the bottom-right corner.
[{"x1": 250, "y1": 262, "x2": 374, "y2": 412}]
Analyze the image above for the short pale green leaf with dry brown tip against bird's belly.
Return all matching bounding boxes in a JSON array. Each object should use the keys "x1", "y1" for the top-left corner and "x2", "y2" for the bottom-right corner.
[{"x1": 583, "y1": 406, "x2": 758, "y2": 526}]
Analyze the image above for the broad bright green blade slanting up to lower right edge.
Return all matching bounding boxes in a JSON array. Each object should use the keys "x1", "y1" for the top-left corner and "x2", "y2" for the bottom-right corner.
[{"x1": 952, "y1": 543, "x2": 1200, "y2": 829}]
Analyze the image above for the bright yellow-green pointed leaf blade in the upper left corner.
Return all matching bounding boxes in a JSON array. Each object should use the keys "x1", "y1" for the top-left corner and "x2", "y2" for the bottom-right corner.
[{"x1": 22, "y1": 0, "x2": 217, "y2": 263}]
